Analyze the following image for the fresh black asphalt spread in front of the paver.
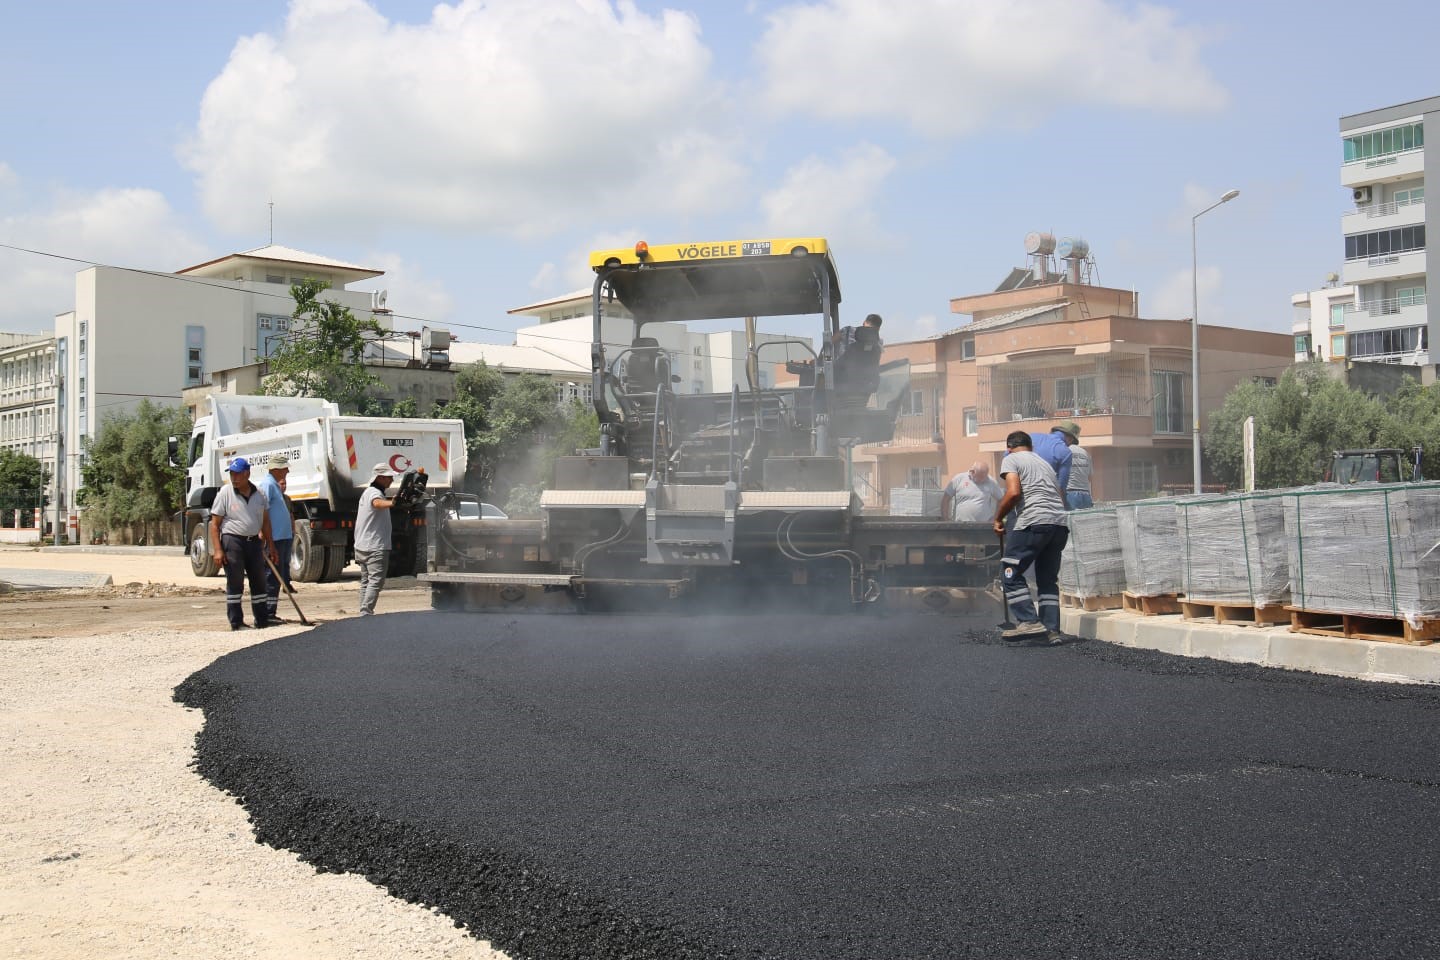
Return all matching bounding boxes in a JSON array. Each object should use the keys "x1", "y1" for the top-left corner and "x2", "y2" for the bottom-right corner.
[{"x1": 176, "y1": 613, "x2": 1440, "y2": 960}]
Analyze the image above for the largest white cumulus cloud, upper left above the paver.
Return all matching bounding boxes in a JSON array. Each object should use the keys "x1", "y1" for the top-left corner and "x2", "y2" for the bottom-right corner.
[{"x1": 181, "y1": 0, "x2": 743, "y2": 236}]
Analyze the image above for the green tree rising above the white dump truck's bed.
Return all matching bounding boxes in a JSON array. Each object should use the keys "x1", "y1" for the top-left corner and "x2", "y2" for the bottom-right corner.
[{"x1": 264, "y1": 279, "x2": 384, "y2": 412}]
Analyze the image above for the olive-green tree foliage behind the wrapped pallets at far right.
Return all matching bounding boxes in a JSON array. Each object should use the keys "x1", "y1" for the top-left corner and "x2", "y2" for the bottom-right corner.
[{"x1": 1205, "y1": 363, "x2": 1440, "y2": 489}]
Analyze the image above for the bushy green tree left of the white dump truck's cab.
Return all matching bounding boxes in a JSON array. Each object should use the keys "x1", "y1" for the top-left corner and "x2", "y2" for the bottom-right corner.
[{"x1": 76, "y1": 400, "x2": 192, "y2": 543}]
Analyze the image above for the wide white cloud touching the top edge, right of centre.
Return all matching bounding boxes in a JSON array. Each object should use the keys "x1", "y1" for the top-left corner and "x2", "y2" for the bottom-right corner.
[{"x1": 757, "y1": 0, "x2": 1227, "y2": 137}]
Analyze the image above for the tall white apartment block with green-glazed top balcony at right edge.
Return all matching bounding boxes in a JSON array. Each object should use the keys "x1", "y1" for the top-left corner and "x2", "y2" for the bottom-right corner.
[{"x1": 1339, "y1": 96, "x2": 1440, "y2": 365}]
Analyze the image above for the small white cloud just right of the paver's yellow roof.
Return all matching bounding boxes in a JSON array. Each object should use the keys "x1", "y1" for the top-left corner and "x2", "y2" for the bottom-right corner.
[{"x1": 760, "y1": 144, "x2": 896, "y2": 249}]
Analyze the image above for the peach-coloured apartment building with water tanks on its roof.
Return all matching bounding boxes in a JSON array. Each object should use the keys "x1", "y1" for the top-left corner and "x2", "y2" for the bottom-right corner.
[{"x1": 852, "y1": 238, "x2": 1295, "y2": 511}]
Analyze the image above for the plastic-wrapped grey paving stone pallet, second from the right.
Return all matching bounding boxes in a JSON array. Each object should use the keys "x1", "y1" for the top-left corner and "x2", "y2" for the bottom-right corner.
[{"x1": 1175, "y1": 494, "x2": 1290, "y2": 625}]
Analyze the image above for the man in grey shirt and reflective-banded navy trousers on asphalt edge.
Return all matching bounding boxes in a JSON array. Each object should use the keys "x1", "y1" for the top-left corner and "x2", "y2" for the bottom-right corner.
[{"x1": 995, "y1": 430, "x2": 1070, "y2": 643}]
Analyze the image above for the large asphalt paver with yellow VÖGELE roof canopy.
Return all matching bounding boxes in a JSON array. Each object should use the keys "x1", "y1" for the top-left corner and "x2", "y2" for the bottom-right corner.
[{"x1": 420, "y1": 237, "x2": 999, "y2": 610}]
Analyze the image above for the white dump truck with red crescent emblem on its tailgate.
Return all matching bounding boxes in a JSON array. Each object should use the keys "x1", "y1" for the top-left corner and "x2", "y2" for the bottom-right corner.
[{"x1": 170, "y1": 394, "x2": 467, "y2": 583}]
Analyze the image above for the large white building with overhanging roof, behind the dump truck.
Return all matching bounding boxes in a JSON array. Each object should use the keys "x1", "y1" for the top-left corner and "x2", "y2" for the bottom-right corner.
[{"x1": 55, "y1": 245, "x2": 390, "y2": 514}]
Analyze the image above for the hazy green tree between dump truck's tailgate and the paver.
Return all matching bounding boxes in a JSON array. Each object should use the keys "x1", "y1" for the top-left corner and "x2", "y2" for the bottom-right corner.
[{"x1": 432, "y1": 361, "x2": 599, "y2": 514}]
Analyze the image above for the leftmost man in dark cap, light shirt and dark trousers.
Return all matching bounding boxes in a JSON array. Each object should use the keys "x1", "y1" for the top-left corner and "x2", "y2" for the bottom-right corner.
[{"x1": 210, "y1": 456, "x2": 275, "y2": 630}]
